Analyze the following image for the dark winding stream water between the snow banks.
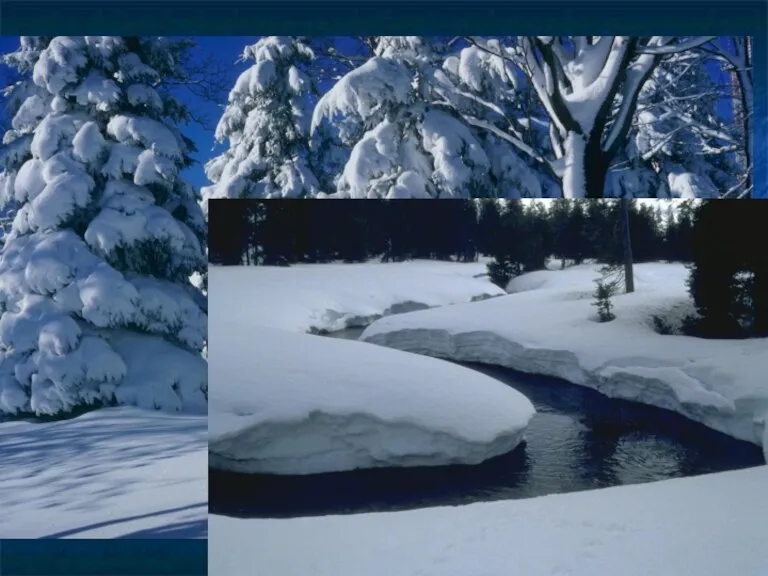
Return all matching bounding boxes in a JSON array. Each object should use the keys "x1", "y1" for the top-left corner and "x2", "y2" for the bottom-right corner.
[{"x1": 209, "y1": 328, "x2": 763, "y2": 517}]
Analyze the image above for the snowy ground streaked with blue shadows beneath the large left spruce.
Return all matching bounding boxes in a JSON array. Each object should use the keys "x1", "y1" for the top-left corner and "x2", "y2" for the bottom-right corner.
[{"x1": 0, "y1": 406, "x2": 208, "y2": 539}]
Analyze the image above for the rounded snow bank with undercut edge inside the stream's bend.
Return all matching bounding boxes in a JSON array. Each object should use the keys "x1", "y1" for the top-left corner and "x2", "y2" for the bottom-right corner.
[{"x1": 208, "y1": 322, "x2": 534, "y2": 474}]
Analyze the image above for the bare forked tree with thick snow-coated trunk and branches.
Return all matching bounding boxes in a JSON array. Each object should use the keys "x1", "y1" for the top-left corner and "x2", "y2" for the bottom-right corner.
[{"x1": 468, "y1": 36, "x2": 715, "y2": 198}]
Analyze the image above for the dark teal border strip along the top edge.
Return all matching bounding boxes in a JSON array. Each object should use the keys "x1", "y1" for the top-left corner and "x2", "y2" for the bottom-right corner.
[{"x1": 0, "y1": 0, "x2": 768, "y2": 36}]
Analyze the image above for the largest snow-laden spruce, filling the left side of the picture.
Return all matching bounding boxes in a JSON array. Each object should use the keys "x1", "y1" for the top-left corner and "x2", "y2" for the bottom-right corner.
[{"x1": 0, "y1": 36, "x2": 207, "y2": 414}]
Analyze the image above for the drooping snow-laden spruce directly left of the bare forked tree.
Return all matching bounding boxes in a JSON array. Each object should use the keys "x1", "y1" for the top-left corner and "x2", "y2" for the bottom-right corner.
[{"x1": 312, "y1": 36, "x2": 498, "y2": 198}]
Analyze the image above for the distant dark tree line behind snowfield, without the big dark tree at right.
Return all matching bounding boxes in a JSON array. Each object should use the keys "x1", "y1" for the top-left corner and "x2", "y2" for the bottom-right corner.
[{"x1": 209, "y1": 199, "x2": 693, "y2": 273}]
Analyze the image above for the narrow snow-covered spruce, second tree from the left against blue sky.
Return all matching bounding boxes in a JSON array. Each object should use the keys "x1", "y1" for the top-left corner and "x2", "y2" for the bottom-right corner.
[{"x1": 202, "y1": 36, "x2": 319, "y2": 211}]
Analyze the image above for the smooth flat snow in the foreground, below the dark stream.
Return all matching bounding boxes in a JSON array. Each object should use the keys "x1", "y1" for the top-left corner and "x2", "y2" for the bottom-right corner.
[{"x1": 209, "y1": 466, "x2": 768, "y2": 576}]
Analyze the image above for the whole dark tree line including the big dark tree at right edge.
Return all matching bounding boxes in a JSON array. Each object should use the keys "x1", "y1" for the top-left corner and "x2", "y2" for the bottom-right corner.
[{"x1": 209, "y1": 199, "x2": 768, "y2": 338}]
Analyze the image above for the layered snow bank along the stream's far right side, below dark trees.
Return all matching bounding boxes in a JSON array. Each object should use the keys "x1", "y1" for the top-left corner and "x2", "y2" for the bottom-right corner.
[{"x1": 361, "y1": 264, "x2": 768, "y2": 452}]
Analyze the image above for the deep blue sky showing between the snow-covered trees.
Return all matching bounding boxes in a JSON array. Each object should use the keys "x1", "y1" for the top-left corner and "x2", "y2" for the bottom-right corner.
[{"x1": 0, "y1": 36, "x2": 730, "y2": 188}]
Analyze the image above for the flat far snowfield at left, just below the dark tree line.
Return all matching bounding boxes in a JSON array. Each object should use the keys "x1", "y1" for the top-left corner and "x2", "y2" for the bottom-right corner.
[{"x1": 208, "y1": 260, "x2": 504, "y2": 332}]
